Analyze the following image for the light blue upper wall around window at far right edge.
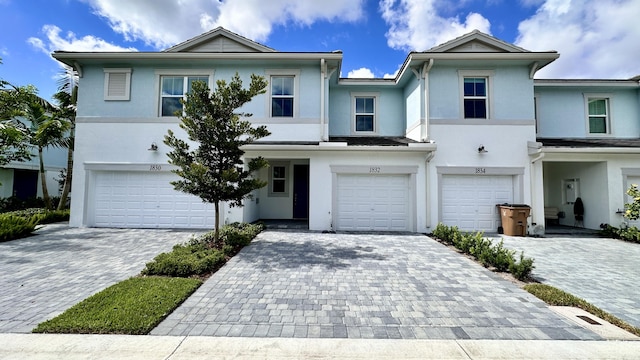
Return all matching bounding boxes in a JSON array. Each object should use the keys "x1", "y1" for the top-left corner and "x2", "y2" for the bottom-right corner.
[{"x1": 535, "y1": 86, "x2": 640, "y2": 138}]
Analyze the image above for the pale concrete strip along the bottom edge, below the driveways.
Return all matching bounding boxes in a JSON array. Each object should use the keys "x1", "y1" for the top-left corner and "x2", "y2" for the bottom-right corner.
[{"x1": 0, "y1": 334, "x2": 640, "y2": 360}]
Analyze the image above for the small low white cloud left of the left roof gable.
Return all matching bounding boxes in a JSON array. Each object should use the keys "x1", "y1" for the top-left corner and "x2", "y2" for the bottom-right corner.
[{"x1": 27, "y1": 25, "x2": 136, "y2": 55}]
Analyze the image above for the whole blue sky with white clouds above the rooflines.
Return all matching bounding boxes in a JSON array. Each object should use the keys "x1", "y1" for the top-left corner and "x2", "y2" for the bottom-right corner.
[{"x1": 0, "y1": 0, "x2": 640, "y2": 98}]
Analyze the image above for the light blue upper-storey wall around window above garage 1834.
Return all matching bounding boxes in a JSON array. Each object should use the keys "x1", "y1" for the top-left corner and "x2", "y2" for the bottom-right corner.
[{"x1": 429, "y1": 66, "x2": 534, "y2": 120}]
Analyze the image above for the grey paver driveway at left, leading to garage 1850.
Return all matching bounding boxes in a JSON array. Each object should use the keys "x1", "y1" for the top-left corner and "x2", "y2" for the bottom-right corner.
[{"x1": 0, "y1": 224, "x2": 200, "y2": 333}]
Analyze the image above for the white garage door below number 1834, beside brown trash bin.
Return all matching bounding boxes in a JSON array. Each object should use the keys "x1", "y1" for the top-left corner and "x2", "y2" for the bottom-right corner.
[{"x1": 441, "y1": 175, "x2": 513, "y2": 232}]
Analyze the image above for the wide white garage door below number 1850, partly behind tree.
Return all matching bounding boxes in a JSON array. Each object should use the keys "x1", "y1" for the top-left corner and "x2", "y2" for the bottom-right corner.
[{"x1": 93, "y1": 171, "x2": 214, "y2": 229}]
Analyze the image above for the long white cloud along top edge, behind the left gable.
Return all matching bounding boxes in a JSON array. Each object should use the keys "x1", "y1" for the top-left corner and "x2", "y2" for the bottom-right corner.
[{"x1": 83, "y1": 0, "x2": 364, "y2": 49}]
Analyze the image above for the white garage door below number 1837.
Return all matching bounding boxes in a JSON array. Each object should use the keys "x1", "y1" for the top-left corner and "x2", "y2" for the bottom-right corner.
[{"x1": 336, "y1": 174, "x2": 412, "y2": 231}]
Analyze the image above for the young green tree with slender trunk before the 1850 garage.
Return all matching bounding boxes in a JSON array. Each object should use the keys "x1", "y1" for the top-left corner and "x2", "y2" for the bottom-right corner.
[{"x1": 164, "y1": 73, "x2": 270, "y2": 241}]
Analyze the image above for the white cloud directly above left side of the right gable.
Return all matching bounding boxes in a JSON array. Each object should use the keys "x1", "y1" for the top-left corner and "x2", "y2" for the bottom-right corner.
[{"x1": 380, "y1": 0, "x2": 491, "y2": 51}]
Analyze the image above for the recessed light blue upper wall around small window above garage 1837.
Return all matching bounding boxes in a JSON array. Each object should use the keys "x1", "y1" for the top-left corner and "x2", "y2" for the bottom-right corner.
[{"x1": 329, "y1": 86, "x2": 405, "y2": 136}]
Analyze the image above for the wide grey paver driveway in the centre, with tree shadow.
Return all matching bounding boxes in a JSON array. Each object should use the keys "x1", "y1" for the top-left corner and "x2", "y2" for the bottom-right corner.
[{"x1": 152, "y1": 231, "x2": 600, "y2": 339}]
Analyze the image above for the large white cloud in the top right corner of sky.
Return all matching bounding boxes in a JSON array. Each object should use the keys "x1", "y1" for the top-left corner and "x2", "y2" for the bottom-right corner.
[{"x1": 516, "y1": 0, "x2": 640, "y2": 78}]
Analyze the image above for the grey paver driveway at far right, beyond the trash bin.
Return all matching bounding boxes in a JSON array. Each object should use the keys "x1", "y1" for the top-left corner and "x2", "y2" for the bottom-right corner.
[{"x1": 502, "y1": 236, "x2": 640, "y2": 328}]
